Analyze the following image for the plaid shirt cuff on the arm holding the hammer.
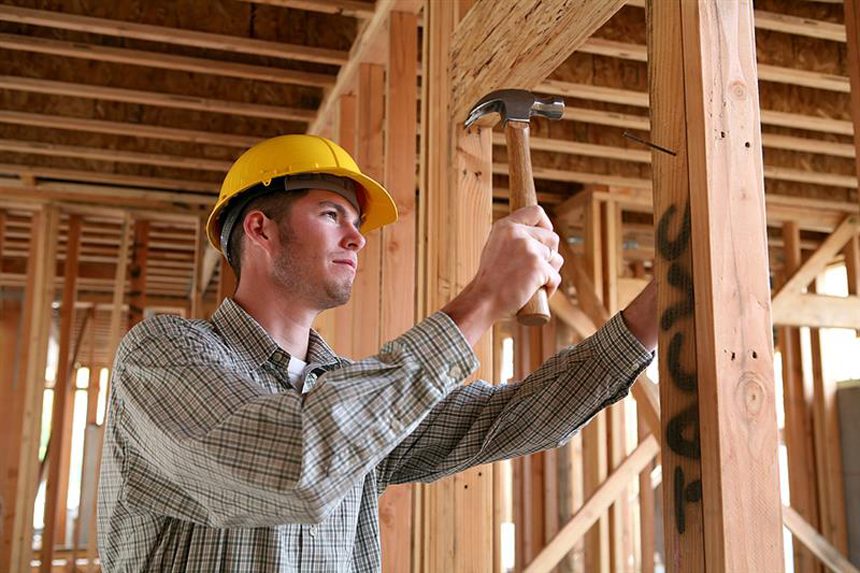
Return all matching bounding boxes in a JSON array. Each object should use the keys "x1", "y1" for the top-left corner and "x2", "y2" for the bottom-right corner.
[{"x1": 383, "y1": 311, "x2": 479, "y2": 394}]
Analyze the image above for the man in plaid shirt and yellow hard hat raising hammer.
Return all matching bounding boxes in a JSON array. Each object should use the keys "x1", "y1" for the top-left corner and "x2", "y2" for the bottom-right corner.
[{"x1": 99, "y1": 135, "x2": 656, "y2": 572}]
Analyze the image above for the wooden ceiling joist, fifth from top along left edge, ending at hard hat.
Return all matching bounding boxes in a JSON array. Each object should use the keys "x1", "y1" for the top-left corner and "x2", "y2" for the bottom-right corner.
[{"x1": 0, "y1": 139, "x2": 232, "y2": 173}]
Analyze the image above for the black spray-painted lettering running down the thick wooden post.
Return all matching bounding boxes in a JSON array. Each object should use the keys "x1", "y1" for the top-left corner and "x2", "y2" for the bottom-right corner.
[{"x1": 657, "y1": 201, "x2": 702, "y2": 535}]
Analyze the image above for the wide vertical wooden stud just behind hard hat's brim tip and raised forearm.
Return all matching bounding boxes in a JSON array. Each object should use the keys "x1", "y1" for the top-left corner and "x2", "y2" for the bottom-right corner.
[{"x1": 379, "y1": 12, "x2": 418, "y2": 571}]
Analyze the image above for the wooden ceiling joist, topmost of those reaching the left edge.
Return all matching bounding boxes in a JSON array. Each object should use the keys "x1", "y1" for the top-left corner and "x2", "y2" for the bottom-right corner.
[{"x1": 0, "y1": 6, "x2": 347, "y2": 66}]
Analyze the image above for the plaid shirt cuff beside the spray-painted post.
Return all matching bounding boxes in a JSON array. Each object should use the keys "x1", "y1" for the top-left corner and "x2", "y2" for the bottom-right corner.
[{"x1": 594, "y1": 312, "x2": 654, "y2": 386}]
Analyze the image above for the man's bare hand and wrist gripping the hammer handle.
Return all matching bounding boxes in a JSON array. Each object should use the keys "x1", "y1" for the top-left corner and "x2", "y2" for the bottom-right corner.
[{"x1": 442, "y1": 206, "x2": 564, "y2": 345}]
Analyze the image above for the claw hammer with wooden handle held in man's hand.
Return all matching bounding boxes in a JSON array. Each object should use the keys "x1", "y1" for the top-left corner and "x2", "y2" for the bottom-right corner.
[{"x1": 465, "y1": 90, "x2": 564, "y2": 326}]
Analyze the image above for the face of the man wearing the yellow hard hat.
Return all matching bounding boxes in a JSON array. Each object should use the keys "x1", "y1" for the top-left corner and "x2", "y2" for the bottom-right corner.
[{"x1": 272, "y1": 189, "x2": 365, "y2": 310}]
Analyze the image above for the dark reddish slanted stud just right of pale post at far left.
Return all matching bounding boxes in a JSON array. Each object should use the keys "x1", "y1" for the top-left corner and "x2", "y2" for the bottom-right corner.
[{"x1": 41, "y1": 215, "x2": 82, "y2": 573}]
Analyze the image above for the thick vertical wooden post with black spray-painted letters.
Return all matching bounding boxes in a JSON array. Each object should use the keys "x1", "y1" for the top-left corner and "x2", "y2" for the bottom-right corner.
[{"x1": 646, "y1": 0, "x2": 783, "y2": 572}]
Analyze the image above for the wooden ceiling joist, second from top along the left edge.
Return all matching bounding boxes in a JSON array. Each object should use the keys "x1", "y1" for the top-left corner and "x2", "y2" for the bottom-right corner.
[{"x1": 0, "y1": 34, "x2": 334, "y2": 87}]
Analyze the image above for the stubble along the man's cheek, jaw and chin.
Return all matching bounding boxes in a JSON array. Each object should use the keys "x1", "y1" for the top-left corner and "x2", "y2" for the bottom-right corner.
[{"x1": 272, "y1": 222, "x2": 353, "y2": 310}]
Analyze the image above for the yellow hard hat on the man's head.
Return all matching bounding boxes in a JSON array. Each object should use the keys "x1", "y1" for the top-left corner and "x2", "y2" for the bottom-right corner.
[{"x1": 206, "y1": 135, "x2": 397, "y2": 254}]
